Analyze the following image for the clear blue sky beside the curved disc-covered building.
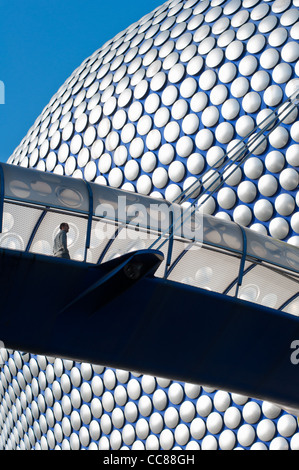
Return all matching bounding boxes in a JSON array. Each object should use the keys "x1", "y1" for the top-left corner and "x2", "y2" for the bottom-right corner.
[{"x1": 0, "y1": 0, "x2": 164, "y2": 162}]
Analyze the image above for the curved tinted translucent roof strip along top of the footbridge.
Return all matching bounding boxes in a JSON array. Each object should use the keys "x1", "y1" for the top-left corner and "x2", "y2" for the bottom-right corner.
[{"x1": 0, "y1": 163, "x2": 299, "y2": 274}]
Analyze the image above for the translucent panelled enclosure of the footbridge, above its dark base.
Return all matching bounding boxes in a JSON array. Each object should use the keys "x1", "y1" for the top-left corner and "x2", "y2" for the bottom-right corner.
[{"x1": 0, "y1": 164, "x2": 299, "y2": 316}]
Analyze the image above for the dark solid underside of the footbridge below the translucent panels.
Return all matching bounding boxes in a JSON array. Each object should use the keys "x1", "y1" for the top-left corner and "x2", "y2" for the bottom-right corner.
[{"x1": 0, "y1": 249, "x2": 299, "y2": 409}]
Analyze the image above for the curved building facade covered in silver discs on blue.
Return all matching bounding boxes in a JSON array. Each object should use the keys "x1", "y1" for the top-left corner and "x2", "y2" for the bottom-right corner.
[{"x1": 0, "y1": 0, "x2": 299, "y2": 450}]
